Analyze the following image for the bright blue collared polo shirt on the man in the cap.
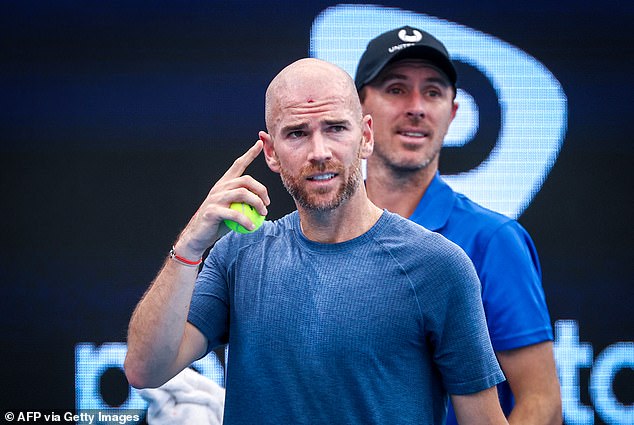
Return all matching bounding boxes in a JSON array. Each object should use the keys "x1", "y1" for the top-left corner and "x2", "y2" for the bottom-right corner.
[{"x1": 410, "y1": 174, "x2": 553, "y2": 425}]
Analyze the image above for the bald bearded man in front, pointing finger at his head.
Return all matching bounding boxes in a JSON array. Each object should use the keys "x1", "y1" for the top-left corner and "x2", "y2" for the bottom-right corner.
[{"x1": 125, "y1": 59, "x2": 506, "y2": 424}]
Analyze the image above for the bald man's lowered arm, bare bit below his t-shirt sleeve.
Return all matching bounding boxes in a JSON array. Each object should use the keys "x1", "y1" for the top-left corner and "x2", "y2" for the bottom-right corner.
[{"x1": 451, "y1": 387, "x2": 508, "y2": 425}]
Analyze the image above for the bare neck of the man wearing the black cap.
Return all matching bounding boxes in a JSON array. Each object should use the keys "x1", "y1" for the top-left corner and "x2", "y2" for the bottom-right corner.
[{"x1": 366, "y1": 161, "x2": 438, "y2": 218}]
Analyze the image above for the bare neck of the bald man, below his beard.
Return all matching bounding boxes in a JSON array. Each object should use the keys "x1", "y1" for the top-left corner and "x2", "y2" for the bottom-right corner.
[{"x1": 298, "y1": 185, "x2": 383, "y2": 243}]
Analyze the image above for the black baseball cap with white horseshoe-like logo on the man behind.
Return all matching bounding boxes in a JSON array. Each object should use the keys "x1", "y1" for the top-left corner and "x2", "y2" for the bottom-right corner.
[{"x1": 354, "y1": 26, "x2": 458, "y2": 90}]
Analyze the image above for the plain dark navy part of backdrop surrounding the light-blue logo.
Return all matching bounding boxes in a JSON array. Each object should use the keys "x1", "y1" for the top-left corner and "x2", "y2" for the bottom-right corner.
[{"x1": 0, "y1": 0, "x2": 634, "y2": 423}]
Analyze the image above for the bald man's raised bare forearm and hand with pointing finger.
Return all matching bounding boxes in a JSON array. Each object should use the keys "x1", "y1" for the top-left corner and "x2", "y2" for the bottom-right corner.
[{"x1": 124, "y1": 140, "x2": 270, "y2": 388}]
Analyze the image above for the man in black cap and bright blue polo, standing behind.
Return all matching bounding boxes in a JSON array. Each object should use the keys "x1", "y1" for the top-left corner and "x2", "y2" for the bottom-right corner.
[{"x1": 355, "y1": 26, "x2": 562, "y2": 425}]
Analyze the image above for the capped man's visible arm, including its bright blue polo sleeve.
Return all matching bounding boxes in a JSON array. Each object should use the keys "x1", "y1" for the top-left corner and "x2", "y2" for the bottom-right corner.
[{"x1": 479, "y1": 221, "x2": 562, "y2": 425}]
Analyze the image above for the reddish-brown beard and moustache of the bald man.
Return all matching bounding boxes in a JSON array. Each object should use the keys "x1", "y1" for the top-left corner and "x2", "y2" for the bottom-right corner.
[{"x1": 280, "y1": 152, "x2": 363, "y2": 212}]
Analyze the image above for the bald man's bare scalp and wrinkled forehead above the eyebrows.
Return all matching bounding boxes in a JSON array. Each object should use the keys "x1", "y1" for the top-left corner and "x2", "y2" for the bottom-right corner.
[{"x1": 265, "y1": 58, "x2": 362, "y2": 135}]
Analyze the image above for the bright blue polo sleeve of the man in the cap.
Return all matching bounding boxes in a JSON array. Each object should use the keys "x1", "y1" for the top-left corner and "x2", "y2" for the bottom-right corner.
[{"x1": 480, "y1": 221, "x2": 553, "y2": 351}]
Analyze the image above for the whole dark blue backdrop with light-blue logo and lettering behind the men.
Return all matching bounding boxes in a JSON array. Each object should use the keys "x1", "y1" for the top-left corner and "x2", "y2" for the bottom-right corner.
[{"x1": 0, "y1": 0, "x2": 634, "y2": 424}]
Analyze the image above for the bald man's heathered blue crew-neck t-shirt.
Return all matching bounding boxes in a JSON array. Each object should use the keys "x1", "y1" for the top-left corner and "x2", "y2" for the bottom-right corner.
[{"x1": 188, "y1": 212, "x2": 504, "y2": 424}]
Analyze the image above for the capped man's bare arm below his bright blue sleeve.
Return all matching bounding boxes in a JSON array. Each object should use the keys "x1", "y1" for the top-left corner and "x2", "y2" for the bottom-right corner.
[{"x1": 496, "y1": 341, "x2": 563, "y2": 425}]
